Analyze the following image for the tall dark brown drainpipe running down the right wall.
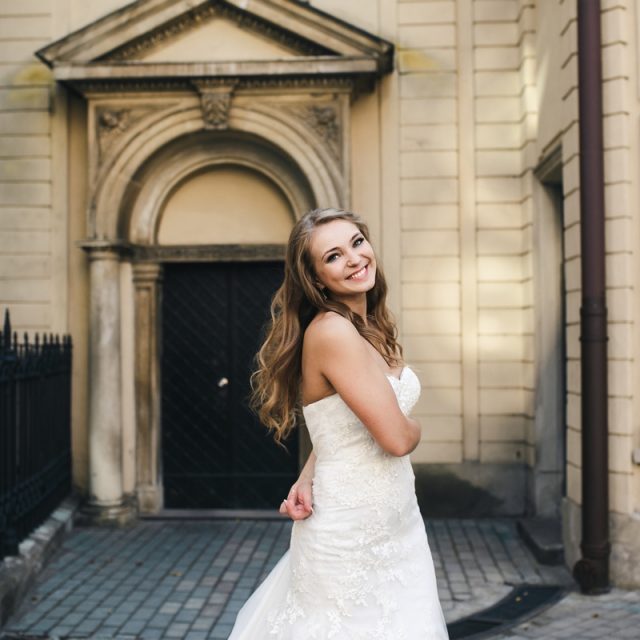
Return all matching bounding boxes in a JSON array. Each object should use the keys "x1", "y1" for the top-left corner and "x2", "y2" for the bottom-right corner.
[{"x1": 573, "y1": 0, "x2": 611, "y2": 594}]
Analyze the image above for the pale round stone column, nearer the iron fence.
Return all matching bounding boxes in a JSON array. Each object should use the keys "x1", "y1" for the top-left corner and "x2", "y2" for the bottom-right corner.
[{"x1": 83, "y1": 242, "x2": 135, "y2": 524}]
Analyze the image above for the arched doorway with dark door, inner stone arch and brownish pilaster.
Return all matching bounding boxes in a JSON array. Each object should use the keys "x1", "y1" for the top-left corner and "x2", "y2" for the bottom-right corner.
[{"x1": 129, "y1": 130, "x2": 316, "y2": 512}]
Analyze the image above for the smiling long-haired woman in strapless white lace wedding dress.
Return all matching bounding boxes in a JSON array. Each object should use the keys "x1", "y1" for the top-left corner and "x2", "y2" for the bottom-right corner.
[{"x1": 229, "y1": 209, "x2": 447, "y2": 640}]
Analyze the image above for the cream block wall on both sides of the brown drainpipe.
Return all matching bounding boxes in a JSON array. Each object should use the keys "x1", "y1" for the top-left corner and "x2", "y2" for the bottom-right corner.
[{"x1": 560, "y1": 1, "x2": 640, "y2": 586}]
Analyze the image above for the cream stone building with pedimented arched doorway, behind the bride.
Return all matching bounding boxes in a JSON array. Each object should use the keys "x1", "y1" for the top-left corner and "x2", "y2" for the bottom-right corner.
[{"x1": 0, "y1": 0, "x2": 640, "y2": 586}]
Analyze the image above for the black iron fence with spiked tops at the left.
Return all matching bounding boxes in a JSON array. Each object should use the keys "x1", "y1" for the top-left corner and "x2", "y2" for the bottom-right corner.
[{"x1": 0, "y1": 311, "x2": 72, "y2": 558}]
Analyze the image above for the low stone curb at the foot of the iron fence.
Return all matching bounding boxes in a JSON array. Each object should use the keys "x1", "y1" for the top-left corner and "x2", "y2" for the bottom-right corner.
[{"x1": 0, "y1": 496, "x2": 80, "y2": 627}]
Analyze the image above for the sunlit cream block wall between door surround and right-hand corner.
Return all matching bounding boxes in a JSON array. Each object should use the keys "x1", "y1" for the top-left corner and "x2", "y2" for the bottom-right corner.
[{"x1": 362, "y1": 0, "x2": 534, "y2": 513}]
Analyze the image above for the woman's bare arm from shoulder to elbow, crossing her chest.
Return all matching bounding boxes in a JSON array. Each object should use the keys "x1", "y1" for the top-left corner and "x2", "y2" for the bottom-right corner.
[{"x1": 305, "y1": 313, "x2": 420, "y2": 456}]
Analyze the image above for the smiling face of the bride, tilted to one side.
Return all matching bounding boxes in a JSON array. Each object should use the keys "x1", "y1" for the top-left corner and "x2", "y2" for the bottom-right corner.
[{"x1": 309, "y1": 219, "x2": 376, "y2": 302}]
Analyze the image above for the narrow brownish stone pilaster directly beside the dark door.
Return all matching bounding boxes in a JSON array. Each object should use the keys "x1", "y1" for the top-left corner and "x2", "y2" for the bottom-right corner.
[{"x1": 133, "y1": 263, "x2": 163, "y2": 513}]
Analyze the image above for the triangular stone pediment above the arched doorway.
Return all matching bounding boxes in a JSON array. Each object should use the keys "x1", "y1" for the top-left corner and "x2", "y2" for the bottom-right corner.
[{"x1": 37, "y1": 0, "x2": 393, "y2": 82}]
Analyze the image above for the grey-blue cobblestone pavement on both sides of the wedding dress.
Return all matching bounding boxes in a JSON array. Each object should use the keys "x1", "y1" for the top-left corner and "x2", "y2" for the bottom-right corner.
[{"x1": 5, "y1": 520, "x2": 640, "y2": 640}]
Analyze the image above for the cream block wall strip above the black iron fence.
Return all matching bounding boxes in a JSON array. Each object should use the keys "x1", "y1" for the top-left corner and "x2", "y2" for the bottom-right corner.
[{"x1": 0, "y1": 0, "x2": 53, "y2": 332}]
